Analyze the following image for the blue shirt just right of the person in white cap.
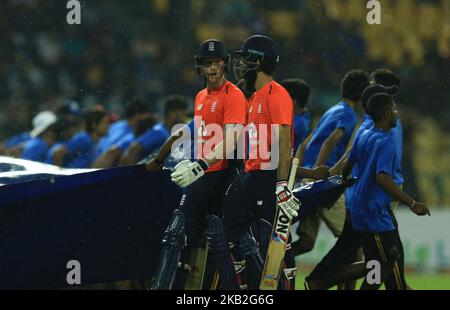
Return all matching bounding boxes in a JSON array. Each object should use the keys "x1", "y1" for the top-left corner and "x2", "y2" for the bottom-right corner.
[{"x1": 64, "y1": 131, "x2": 96, "y2": 168}]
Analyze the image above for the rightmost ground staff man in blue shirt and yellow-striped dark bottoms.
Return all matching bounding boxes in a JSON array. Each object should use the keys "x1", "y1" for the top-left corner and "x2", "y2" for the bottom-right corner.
[{"x1": 343, "y1": 94, "x2": 430, "y2": 289}]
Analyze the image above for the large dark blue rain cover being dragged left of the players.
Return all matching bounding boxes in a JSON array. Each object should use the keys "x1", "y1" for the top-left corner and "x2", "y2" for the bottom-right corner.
[{"x1": 0, "y1": 165, "x2": 181, "y2": 289}]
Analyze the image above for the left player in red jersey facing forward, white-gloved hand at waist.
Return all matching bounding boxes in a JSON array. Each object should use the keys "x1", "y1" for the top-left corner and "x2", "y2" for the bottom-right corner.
[{"x1": 153, "y1": 40, "x2": 247, "y2": 289}]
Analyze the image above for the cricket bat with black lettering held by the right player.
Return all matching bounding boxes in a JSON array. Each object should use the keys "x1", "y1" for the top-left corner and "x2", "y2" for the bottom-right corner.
[{"x1": 259, "y1": 158, "x2": 299, "y2": 290}]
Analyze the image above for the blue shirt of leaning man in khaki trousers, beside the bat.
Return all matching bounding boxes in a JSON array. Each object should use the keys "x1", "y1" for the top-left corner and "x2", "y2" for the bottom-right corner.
[{"x1": 302, "y1": 101, "x2": 358, "y2": 168}]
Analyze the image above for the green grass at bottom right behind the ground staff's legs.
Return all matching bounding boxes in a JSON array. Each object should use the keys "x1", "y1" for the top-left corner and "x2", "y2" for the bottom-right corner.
[{"x1": 296, "y1": 272, "x2": 450, "y2": 290}]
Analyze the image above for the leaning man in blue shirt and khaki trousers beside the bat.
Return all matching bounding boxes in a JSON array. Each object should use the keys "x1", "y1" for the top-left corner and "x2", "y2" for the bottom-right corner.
[{"x1": 292, "y1": 70, "x2": 369, "y2": 255}]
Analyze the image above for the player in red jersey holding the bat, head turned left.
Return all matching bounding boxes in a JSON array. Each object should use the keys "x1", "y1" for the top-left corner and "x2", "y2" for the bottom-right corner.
[{"x1": 174, "y1": 35, "x2": 300, "y2": 289}]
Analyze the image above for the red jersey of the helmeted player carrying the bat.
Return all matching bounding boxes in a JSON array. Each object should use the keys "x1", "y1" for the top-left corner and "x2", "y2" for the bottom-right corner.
[{"x1": 245, "y1": 81, "x2": 294, "y2": 172}]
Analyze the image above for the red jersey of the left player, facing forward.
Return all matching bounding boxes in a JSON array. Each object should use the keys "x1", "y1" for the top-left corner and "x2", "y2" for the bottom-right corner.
[{"x1": 194, "y1": 81, "x2": 247, "y2": 173}]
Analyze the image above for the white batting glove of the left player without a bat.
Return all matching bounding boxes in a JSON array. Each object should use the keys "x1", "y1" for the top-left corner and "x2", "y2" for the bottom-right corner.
[{"x1": 170, "y1": 159, "x2": 208, "y2": 187}]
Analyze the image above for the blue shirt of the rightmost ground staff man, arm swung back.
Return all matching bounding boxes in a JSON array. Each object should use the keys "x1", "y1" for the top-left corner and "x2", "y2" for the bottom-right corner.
[{"x1": 348, "y1": 127, "x2": 398, "y2": 232}]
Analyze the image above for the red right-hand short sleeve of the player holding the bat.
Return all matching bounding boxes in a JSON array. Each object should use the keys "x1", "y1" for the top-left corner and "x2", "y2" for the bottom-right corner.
[{"x1": 269, "y1": 90, "x2": 294, "y2": 126}]
